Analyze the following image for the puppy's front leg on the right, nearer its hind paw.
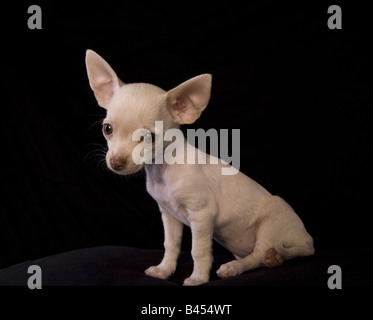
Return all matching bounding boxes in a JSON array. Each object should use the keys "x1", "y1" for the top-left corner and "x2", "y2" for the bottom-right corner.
[{"x1": 184, "y1": 215, "x2": 214, "y2": 286}]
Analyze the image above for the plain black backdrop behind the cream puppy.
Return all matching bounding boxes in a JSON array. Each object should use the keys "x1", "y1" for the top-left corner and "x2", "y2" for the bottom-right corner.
[{"x1": 0, "y1": 1, "x2": 373, "y2": 276}]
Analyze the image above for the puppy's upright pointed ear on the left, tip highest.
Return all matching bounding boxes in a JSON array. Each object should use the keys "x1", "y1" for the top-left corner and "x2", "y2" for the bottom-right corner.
[{"x1": 85, "y1": 50, "x2": 121, "y2": 109}]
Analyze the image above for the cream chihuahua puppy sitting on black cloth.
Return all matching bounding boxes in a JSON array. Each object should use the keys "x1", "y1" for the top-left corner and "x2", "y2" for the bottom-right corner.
[{"x1": 86, "y1": 50, "x2": 314, "y2": 285}]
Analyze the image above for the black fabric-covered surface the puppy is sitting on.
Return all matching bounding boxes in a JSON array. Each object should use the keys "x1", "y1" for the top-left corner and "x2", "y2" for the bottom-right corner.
[{"x1": 0, "y1": 246, "x2": 373, "y2": 288}]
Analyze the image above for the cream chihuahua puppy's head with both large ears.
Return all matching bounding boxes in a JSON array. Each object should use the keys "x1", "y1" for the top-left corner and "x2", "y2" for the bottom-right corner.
[{"x1": 86, "y1": 50, "x2": 211, "y2": 174}]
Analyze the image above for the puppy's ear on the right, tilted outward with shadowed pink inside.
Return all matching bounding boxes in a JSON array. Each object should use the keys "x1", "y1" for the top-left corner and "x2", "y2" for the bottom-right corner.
[{"x1": 167, "y1": 74, "x2": 212, "y2": 124}]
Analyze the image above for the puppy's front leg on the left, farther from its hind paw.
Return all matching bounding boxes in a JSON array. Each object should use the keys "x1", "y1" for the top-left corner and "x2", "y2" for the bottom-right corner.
[{"x1": 145, "y1": 209, "x2": 184, "y2": 279}]
